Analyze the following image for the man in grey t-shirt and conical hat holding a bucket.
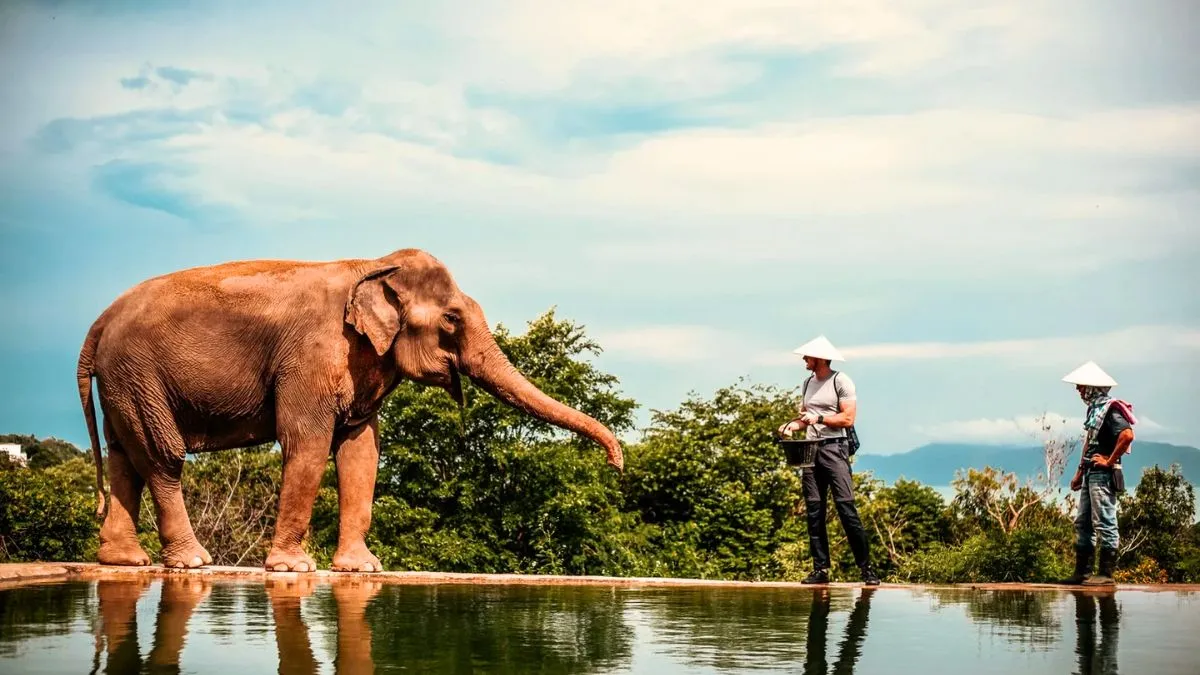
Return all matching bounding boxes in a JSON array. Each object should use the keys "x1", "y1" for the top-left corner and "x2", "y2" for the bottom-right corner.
[{"x1": 779, "y1": 335, "x2": 880, "y2": 586}]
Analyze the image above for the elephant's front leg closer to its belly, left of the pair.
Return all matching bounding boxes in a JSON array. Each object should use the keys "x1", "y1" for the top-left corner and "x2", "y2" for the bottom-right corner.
[{"x1": 265, "y1": 424, "x2": 334, "y2": 572}]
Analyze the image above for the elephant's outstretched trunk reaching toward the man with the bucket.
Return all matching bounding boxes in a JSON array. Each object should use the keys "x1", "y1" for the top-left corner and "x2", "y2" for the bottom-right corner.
[{"x1": 462, "y1": 319, "x2": 625, "y2": 471}]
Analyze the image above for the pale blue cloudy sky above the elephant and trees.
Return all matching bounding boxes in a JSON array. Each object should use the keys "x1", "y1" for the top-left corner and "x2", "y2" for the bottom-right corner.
[{"x1": 0, "y1": 0, "x2": 1200, "y2": 454}]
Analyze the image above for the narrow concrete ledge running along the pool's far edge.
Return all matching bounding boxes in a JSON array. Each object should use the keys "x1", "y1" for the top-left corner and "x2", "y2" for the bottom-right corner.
[{"x1": 0, "y1": 562, "x2": 1200, "y2": 592}]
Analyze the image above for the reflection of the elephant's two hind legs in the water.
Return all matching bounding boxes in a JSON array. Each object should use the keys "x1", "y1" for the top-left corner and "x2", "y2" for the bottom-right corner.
[{"x1": 91, "y1": 574, "x2": 212, "y2": 675}]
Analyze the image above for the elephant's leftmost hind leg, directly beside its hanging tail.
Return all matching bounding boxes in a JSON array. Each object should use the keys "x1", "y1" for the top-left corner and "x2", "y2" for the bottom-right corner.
[{"x1": 96, "y1": 424, "x2": 150, "y2": 566}]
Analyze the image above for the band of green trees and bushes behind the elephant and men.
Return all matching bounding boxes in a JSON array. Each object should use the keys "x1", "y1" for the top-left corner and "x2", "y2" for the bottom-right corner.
[{"x1": 0, "y1": 311, "x2": 1200, "y2": 583}]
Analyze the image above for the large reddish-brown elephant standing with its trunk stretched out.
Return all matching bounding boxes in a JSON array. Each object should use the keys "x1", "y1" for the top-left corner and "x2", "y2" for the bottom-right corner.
[{"x1": 77, "y1": 243, "x2": 624, "y2": 572}]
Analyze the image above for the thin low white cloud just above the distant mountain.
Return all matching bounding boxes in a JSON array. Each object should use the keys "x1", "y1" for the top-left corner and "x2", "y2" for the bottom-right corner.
[{"x1": 913, "y1": 410, "x2": 1166, "y2": 443}]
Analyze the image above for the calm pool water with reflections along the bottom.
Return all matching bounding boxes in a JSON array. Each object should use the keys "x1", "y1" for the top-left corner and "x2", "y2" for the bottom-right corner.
[{"x1": 0, "y1": 575, "x2": 1200, "y2": 675}]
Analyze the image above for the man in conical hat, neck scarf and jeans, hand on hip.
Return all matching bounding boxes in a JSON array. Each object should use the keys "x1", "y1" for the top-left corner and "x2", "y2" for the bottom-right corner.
[{"x1": 1062, "y1": 362, "x2": 1138, "y2": 586}]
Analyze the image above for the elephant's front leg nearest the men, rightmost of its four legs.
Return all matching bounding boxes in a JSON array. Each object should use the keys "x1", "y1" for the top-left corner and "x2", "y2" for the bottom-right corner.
[{"x1": 332, "y1": 422, "x2": 383, "y2": 572}]
